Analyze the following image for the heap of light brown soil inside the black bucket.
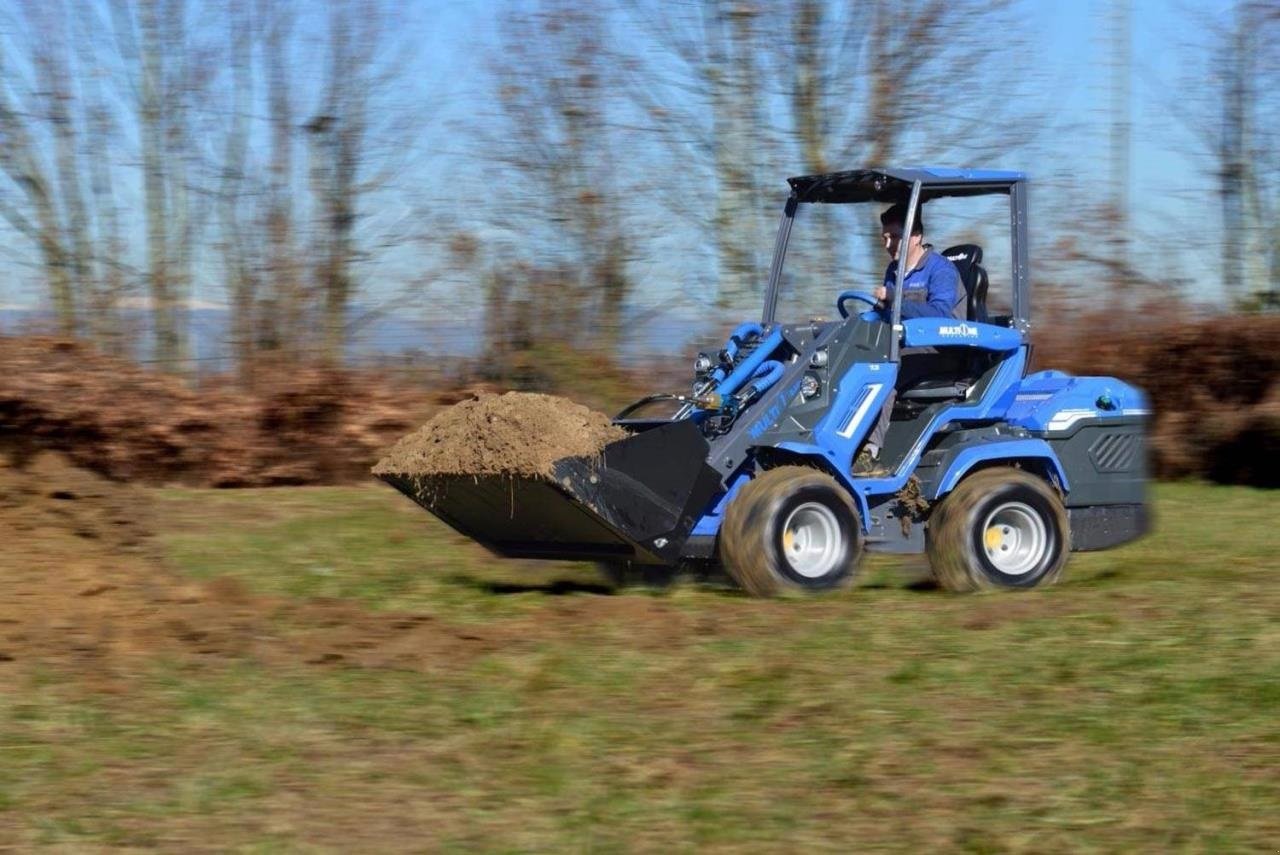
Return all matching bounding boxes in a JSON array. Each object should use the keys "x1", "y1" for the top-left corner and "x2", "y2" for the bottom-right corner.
[{"x1": 374, "y1": 392, "x2": 627, "y2": 476}]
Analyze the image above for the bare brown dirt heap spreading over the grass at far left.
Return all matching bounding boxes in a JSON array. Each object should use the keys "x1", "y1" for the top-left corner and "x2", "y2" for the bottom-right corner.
[{"x1": 0, "y1": 444, "x2": 511, "y2": 691}]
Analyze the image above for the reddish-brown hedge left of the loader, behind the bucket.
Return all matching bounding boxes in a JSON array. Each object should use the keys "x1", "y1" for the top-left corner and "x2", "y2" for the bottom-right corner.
[{"x1": 0, "y1": 337, "x2": 434, "y2": 486}]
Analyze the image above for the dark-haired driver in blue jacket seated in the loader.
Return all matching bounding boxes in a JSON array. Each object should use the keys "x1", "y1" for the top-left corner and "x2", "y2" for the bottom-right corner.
[{"x1": 854, "y1": 204, "x2": 966, "y2": 475}]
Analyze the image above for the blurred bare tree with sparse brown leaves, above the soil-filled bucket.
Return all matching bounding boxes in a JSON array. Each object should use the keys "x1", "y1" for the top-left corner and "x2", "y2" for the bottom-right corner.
[{"x1": 485, "y1": 0, "x2": 631, "y2": 346}]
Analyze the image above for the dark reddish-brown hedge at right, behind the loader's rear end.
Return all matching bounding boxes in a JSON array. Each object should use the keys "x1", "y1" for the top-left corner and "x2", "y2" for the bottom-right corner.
[{"x1": 1036, "y1": 315, "x2": 1280, "y2": 486}]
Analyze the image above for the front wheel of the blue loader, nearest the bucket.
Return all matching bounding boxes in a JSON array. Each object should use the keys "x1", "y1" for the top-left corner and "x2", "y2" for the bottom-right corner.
[{"x1": 719, "y1": 466, "x2": 863, "y2": 596}]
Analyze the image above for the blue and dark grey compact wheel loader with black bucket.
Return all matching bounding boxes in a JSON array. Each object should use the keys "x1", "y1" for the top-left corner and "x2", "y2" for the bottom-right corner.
[{"x1": 383, "y1": 168, "x2": 1149, "y2": 596}]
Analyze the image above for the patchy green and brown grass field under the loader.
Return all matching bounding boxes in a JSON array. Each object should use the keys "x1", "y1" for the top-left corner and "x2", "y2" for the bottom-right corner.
[{"x1": 0, "y1": 485, "x2": 1280, "y2": 852}]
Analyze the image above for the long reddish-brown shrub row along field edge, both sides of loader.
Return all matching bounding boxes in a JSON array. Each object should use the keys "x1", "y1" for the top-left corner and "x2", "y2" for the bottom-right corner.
[{"x1": 0, "y1": 314, "x2": 1280, "y2": 486}]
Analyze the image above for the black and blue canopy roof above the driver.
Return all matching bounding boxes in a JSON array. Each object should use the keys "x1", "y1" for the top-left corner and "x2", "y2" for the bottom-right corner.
[{"x1": 787, "y1": 166, "x2": 1027, "y2": 202}]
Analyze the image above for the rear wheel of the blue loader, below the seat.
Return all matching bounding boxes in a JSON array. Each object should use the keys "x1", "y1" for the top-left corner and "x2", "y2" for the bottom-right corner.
[{"x1": 925, "y1": 466, "x2": 1071, "y2": 593}]
